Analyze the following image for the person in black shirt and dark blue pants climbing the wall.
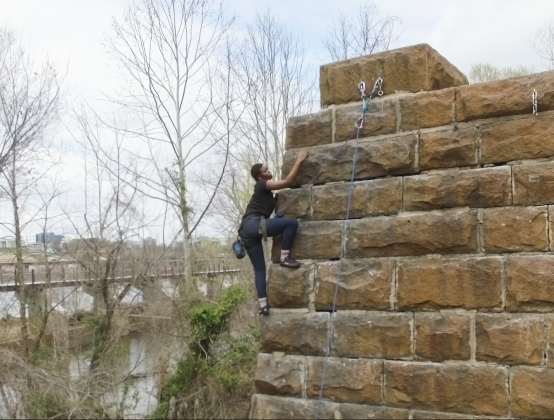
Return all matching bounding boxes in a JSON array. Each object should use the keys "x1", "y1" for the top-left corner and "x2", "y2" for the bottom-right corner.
[{"x1": 239, "y1": 150, "x2": 310, "y2": 316}]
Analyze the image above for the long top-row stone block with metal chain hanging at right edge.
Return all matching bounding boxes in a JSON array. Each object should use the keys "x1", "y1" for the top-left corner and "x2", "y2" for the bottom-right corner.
[{"x1": 456, "y1": 71, "x2": 554, "y2": 121}]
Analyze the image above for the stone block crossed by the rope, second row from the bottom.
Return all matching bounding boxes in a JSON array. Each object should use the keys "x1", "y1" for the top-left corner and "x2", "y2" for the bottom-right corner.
[{"x1": 306, "y1": 357, "x2": 383, "y2": 404}]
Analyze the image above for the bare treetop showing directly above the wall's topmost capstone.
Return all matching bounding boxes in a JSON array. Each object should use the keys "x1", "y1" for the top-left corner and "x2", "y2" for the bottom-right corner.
[{"x1": 323, "y1": 3, "x2": 401, "y2": 61}]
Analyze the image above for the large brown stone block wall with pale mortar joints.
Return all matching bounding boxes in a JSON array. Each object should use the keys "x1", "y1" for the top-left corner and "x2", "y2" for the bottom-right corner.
[{"x1": 252, "y1": 45, "x2": 554, "y2": 419}]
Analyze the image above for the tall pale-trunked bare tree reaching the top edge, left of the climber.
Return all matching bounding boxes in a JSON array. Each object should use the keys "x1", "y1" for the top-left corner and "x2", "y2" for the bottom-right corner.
[{"x1": 101, "y1": 0, "x2": 231, "y2": 291}]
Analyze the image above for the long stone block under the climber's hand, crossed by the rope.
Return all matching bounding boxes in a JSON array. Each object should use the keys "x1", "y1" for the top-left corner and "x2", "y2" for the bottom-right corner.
[{"x1": 283, "y1": 134, "x2": 417, "y2": 187}]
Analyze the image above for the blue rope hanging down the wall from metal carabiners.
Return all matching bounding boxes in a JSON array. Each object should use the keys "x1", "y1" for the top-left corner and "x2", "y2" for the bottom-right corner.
[{"x1": 315, "y1": 77, "x2": 383, "y2": 420}]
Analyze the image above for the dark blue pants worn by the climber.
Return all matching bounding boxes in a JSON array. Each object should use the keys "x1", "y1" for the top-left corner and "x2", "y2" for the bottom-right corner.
[{"x1": 239, "y1": 216, "x2": 298, "y2": 299}]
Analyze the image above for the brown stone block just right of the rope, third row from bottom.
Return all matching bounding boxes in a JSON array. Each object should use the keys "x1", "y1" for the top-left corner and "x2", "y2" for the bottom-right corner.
[{"x1": 332, "y1": 312, "x2": 412, "y2": 359}]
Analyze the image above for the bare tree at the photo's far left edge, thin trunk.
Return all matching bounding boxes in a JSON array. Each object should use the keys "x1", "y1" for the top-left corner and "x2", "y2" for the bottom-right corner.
[{"x1": 0, "y1": 30, "x2": 63, "y2": 354}]
